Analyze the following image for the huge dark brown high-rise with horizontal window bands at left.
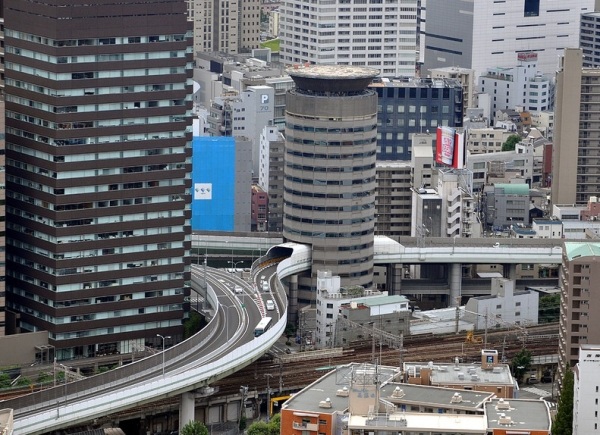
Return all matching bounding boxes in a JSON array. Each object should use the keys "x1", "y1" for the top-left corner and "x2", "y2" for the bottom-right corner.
[{"x1": 5, "y1": 0, "x2": 192, "y2": 359}]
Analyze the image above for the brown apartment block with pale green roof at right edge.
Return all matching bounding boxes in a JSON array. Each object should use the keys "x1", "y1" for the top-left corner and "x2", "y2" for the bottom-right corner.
[{"x1": 557, "y1": 241, "x2": 600, "y2": 380}]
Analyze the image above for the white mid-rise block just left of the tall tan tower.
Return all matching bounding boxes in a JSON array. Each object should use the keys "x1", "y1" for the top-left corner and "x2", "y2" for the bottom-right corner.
[{"x1": 479, "y1": 53, "x2": 554, "y2": 117}]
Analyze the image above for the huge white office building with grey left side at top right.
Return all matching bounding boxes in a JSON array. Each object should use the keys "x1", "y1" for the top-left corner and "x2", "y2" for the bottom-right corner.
[{"x1": 424, "y1": 0, "x2": 594, "y2": 77}]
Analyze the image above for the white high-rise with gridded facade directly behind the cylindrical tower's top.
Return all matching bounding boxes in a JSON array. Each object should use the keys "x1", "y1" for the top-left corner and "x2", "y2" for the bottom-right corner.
[{"x1": 279, "y1": 0, "x2": 420, "y2": 77}]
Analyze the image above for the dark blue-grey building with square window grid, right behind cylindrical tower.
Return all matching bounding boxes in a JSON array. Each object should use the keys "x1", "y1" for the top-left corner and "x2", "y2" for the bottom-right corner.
[{"x1": 370, "y1": 78, "x2": 463, "y2": 161}]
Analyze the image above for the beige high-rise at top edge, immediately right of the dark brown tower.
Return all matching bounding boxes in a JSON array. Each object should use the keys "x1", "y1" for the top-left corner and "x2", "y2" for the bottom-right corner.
[{"x1": 187, "y1": 0, "x2": 261, "y2": 54}]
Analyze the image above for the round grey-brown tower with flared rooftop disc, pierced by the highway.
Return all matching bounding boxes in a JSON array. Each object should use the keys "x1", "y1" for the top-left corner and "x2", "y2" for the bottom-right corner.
[{"x1": 283, "y1": 65, "x2": 378, "y2": 290}]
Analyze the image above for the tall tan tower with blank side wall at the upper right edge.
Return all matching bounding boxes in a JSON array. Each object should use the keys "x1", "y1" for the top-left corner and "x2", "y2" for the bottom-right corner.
[{"x1": 551, "y1": 48, "x2": 600, "y2": 205}]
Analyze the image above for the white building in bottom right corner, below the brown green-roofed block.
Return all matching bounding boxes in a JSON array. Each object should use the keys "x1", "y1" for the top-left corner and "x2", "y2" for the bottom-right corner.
[{"x1": 573, "y1": 344, "x2": 600, "y2": 435}]
